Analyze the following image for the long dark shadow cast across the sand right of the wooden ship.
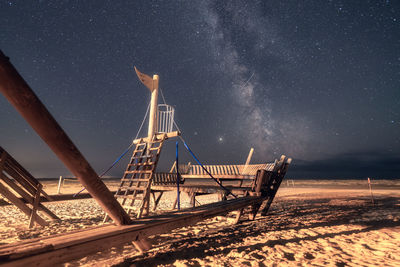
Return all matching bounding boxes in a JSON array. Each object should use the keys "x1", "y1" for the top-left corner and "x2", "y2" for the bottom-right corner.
[{"x1": 115, "y1": 195, "x2": 400, "y2": 266}]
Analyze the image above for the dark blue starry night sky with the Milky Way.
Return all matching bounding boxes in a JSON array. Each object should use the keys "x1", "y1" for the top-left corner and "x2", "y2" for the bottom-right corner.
[{"x1": 0, "y1": 0, "x2": 400, "y2": 178}]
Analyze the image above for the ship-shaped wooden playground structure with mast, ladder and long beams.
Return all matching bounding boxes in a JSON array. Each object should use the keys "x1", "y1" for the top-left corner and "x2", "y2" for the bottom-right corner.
[{"x1": 0, "y1": 57, "x2": 290, "y2": 266}]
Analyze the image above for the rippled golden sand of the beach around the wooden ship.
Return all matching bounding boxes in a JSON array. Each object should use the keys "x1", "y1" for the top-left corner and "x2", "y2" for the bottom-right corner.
[{"x1": 0, "y1": 180, "x2": 400, "y2": 266}]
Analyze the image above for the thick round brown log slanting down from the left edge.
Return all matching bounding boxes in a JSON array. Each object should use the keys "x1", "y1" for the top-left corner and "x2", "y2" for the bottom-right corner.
[{"x1": 0, "y1": 51, "x2": 131, "y2": 224}]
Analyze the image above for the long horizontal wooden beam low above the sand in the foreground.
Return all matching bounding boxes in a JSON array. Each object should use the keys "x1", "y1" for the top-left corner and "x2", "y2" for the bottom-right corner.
[{"x1": 0, "y1": 196, "x2": 266, "y2": 266}]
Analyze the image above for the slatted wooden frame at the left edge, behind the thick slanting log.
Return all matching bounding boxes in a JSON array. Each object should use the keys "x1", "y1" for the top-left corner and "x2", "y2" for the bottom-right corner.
[{"x1": 0, "y1": 147, "x2": 59, "y2": 228}]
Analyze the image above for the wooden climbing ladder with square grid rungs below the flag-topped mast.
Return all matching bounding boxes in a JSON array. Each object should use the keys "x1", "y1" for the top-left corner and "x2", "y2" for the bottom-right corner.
[{"x1": 104, "y1": 135, "x2": 166, "y2": 221}]
